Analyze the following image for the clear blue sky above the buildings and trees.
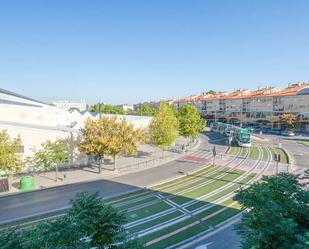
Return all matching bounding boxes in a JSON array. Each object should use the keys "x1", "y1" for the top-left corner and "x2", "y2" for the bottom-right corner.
[{"x1": 0, "y1": 0, "x2": 309, "y2": 103}]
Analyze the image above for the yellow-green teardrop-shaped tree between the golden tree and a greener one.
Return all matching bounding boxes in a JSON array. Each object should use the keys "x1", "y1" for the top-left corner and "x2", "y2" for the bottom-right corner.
[{"x1": 149, "y1": 102, "x2": 178, "y2": 149}]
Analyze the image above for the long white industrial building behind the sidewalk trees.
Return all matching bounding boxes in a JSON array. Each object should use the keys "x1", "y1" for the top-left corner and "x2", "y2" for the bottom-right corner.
[{"x1": 0, "y1": 89, "x2": 151, "y2": 163}]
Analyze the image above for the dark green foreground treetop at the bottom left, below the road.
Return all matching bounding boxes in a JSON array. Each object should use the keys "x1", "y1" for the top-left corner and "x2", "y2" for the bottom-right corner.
[{"x1": 0, "y1": 192, "x2": 141, "y2": 249}]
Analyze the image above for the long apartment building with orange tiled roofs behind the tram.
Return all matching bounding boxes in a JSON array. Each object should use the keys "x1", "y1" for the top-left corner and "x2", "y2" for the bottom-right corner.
[{"x1": 174, "y1": 83, "x2": 309, "y2": 131}]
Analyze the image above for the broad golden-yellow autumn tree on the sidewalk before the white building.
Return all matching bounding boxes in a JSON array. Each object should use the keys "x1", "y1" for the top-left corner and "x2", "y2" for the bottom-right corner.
[{"x1": 80, "y1": 117, "x2": 145, "y2": 170}]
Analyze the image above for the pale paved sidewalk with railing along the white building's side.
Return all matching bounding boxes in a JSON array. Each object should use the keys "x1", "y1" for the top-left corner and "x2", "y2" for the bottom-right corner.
[{"x1": 7, "y1": 137, "x2": 200, "y2": 195}]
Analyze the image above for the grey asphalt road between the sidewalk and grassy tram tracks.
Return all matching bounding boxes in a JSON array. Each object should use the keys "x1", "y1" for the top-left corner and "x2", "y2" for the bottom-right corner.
[{"x1": 0, "y1": 132, "x2": 225, "y2": 225}]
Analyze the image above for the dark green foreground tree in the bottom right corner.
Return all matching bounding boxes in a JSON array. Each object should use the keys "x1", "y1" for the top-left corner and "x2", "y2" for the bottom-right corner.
[{"x1": 235, "y1": 173, "x2": 309, "y2": 249}]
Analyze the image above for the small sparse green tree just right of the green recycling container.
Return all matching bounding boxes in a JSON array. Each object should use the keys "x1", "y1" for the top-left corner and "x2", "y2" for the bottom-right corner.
[{"x1": 34, "y1": 139, "x2": 71, "y2": 170}]
